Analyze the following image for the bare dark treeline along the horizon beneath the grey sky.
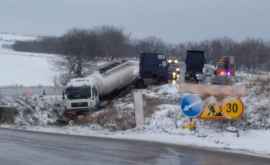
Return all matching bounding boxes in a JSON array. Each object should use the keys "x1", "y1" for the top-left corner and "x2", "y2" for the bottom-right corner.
[{"x1": 13, "y1": 26, "x2": 270, "y2": 77}]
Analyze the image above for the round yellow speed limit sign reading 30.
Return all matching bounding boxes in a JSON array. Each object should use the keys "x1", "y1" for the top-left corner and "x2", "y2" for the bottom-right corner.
[{"x1": 221, "y1": 97, "x2": 245, "y2": 120}]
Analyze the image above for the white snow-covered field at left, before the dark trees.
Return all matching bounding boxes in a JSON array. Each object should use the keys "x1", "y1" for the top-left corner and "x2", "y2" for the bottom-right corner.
[{"x1": 0, "y1": 33, "x2": 56, "y2": 86}]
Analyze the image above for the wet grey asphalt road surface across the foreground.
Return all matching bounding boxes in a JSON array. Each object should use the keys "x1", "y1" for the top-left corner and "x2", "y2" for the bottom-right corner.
[{"x1": 0, "y1": 129, "x2": 270, "y2": 165}]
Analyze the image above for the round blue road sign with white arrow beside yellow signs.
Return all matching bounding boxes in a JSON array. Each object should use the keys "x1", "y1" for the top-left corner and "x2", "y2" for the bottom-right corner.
[{"x1": 180, "y1": 94, "x2": 203, "y2": 118}]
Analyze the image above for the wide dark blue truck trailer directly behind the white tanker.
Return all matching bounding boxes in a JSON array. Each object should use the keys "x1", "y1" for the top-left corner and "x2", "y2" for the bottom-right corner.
[{"x1": 139, "y1": 53, "x2": 169, "y2": 85}]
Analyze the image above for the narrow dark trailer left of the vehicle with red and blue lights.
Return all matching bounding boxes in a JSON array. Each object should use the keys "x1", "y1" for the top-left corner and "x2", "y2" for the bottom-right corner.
[{"x1": 185, "y1": 50, "x2": 206, "y2": 82}]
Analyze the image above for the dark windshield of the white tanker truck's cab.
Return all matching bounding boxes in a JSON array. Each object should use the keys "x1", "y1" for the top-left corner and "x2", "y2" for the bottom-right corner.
[{"x1": 65, "y1": 86, "x2": 91, "y2": 100}]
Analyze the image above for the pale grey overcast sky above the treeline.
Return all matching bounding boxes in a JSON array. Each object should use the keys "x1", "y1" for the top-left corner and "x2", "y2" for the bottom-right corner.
[{"x1": 0, "y1": 0, "x2": 270, "y2": 43}]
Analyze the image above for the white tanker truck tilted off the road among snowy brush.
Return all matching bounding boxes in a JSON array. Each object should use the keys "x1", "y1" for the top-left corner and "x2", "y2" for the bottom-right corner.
[{"x1": 63, "y1": 61, "x2": 139, "y2": 112}]
